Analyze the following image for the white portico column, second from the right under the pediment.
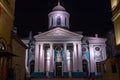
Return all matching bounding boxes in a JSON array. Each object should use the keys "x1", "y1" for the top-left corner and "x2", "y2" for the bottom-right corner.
[{"x1": 73, "y1": 43, "x2": 77, "y2": 72}]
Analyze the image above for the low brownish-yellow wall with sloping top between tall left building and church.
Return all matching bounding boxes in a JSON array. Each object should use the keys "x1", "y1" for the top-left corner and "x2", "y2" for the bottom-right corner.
[{"x1": 12, "y1": 37, "x2": 26, "y2": 80}]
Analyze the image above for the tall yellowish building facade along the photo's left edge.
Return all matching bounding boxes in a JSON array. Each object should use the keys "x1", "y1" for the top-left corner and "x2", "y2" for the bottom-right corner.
[{"x1": 0, "y1": 0, "x2": 15, "y2": 80}]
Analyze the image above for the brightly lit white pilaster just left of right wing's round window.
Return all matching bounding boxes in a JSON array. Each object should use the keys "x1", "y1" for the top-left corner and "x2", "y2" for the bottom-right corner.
[{"x1": 89, "y1": 44, "x2": 95, "y2": 72}]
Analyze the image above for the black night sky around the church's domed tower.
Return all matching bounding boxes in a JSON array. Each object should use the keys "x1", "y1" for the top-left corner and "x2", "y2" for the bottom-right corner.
[{"x1": 14, "y1": 0, "x2": 113, "y2": 38}]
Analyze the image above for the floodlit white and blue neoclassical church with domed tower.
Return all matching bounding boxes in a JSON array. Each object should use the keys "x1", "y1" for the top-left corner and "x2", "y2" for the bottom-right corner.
[{"x1": 23, "y1": 2, "x2": 106, "y2": 77}]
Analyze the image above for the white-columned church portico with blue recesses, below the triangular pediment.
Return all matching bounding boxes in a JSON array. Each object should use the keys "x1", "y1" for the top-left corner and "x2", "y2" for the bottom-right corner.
[{"x1": 34, "y1": 41, "x2": 82, "y2": 76}]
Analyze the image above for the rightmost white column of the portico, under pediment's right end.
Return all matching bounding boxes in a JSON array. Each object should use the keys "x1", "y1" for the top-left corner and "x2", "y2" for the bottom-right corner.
[{"x1": 78, "y1": 42, "x2": 83, "y2": 72}]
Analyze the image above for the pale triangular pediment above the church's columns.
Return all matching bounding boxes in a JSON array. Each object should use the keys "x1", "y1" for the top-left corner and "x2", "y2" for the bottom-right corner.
[{"x1": 34, "y1": 28, "x2": 82, "y2": 40}]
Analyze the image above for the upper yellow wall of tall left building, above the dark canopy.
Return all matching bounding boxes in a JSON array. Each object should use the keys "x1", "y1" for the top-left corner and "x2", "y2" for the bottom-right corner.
[{"x1": 0, "y1": 0, "x2": 15, "y2": 52}]
